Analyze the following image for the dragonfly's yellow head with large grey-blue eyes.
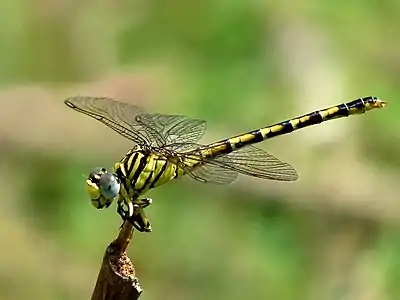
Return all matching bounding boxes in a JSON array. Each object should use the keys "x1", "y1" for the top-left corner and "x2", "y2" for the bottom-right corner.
[{"x1": 86, "y1": 168, "x2": 120, "y2": 209}]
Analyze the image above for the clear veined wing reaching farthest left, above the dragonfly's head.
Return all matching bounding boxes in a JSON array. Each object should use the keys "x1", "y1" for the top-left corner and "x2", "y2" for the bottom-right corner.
[{"x1": 64, "y1": 96, "x2": 156, "y2": 144}]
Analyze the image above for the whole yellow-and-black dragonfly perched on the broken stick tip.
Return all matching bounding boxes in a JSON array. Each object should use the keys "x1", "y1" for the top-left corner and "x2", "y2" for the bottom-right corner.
[{"x1": 64, "y1": 96, "x2": 386, "y2": 232}]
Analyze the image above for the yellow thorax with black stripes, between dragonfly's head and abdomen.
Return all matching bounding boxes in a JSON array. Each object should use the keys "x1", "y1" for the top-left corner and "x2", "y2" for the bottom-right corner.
[{"x1": 115, "y1": 146, "x2": 184, "y2": 197}]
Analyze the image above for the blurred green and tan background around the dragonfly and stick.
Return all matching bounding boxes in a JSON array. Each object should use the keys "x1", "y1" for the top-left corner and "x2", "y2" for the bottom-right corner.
[{"x1": 0, "y1": 0, "x2": 400, "y2": 300}]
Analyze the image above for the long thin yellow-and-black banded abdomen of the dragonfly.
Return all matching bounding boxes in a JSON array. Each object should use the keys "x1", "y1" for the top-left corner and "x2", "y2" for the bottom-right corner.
[{"x1": 203, "y1": 97, "x2": 385, "y2": 158}]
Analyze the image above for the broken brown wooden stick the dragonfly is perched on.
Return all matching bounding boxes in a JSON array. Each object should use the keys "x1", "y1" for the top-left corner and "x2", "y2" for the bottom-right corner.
[{"x1": 91, "y1": 222, "x2": 142, "y2": 300}]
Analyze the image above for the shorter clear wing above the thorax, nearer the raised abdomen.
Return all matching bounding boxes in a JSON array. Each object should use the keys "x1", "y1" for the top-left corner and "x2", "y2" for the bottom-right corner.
[{"x1": 140, "y1": 114, "x2": 207, "y2": 151}]
